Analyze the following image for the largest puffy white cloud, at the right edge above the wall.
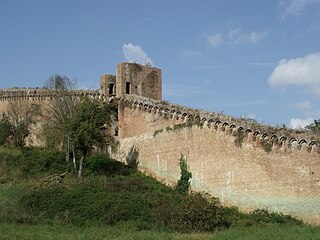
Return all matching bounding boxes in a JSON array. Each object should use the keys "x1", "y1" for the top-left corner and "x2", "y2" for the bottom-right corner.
[{"x1": 268, "y1": 53, "x2": 320, "y2": 96}]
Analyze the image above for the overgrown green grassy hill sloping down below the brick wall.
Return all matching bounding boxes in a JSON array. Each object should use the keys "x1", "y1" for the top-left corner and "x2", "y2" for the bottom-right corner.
[{"x1": 0, "y1": 148, "x2": 320, "y2": 239}]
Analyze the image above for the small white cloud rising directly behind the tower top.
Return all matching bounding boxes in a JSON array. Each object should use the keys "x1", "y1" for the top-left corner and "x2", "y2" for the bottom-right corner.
[{"x1": 122, "y1": 43, "x2": 153, "y2": 65}]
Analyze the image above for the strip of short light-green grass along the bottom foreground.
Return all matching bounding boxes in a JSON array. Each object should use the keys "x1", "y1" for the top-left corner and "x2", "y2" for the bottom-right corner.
[{"x1": 0, "y1": 223, "x2": 320, "y2": 240}]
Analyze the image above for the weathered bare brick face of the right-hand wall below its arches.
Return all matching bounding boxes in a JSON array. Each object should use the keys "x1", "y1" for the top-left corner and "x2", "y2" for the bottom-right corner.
[{"x1": 119, "y1": 102, "x2": 320, "y2": 224}]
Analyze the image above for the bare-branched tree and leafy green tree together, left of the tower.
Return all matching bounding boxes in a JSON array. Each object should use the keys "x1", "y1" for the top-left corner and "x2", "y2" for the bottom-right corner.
[{"x1": 44, "y1": 75, "x2": 116, "y2": 178}]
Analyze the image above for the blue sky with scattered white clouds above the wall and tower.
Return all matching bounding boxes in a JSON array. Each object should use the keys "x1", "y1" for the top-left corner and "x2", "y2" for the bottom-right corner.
[{"x1": 0, "y1": 0, "x2": 320, "y2": 127}]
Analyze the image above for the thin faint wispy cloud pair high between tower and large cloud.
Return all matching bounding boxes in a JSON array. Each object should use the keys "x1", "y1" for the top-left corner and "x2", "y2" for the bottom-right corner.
[{"x1": 228, "y1": 28, "x2": 268, "y2": 45}]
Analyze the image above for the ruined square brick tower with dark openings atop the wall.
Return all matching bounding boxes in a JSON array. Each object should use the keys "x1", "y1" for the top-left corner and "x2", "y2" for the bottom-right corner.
[{"x1": 100, "y1": 62, "x2": 162, "y2": 101}]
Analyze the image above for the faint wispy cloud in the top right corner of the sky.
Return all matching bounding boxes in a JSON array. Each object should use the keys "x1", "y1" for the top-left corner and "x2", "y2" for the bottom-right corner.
[{"x1": 281, "y1": 0, "x2": 317, "y2": 18}]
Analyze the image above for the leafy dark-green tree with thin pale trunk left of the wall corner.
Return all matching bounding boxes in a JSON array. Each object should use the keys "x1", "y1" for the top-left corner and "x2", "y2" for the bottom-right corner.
[{"x1": 69, "y1": 98, "x2": 111, "y2": 178}]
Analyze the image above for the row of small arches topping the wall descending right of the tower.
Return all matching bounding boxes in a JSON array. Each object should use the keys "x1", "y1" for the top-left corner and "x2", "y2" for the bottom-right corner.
[{"x1": 120, "y1": 95, "x2": 319, "y2": 152}]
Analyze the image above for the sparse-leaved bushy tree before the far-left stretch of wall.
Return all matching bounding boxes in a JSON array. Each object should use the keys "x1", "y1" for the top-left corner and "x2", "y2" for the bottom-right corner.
[{"x1": 7, "y1": 101, "x2": 40, "y2": 148}]
